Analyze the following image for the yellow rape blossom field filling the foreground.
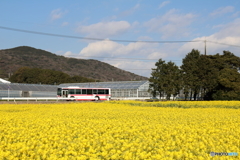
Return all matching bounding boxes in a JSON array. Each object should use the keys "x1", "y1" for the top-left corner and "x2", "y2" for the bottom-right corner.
[{"x1": 0, "y1": 101, "x2": 240, "y2": 160}]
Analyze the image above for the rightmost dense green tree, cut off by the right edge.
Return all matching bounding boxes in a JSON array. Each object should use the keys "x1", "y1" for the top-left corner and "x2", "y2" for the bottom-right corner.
[{"x1": 205, "y1": 51, "x2": 240, "y2": 100}]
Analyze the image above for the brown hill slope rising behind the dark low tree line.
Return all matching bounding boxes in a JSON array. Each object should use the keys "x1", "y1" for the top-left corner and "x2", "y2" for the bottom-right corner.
[{"x1": 0, "y1": 46, "x2": 147, "y2": 81}]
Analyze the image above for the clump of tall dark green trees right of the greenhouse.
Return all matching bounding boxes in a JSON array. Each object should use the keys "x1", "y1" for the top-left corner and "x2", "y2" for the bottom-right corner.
[{"x1": 149, "y1": 49, "x2": 240, "y2": 100}]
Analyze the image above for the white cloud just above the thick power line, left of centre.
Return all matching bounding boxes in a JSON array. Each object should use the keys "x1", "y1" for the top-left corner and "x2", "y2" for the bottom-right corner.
[{"x1": 76, "y1": 21, "x2": 131, "y2": 38}]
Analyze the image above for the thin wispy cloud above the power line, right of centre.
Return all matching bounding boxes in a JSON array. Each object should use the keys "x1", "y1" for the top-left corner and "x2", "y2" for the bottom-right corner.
[{"x1": 144, "y1": 9, "x2": 196, "y2": 39}]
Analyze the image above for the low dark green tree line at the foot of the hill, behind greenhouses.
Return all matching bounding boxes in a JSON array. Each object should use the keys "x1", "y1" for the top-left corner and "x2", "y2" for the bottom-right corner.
[{"x1": 9, "y1": 67, "x2": 99, "y2": 85}]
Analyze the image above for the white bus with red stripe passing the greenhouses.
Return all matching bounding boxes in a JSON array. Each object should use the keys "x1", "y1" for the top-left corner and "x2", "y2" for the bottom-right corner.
[{"x1": 57, "y1": 86, "x2": 111, "y2": 101}]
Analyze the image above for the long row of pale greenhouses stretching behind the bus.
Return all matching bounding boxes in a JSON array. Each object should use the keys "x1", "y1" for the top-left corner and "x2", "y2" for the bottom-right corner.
[{"x1": 0, "y1": 81, "x2": 151, "y2": 99}]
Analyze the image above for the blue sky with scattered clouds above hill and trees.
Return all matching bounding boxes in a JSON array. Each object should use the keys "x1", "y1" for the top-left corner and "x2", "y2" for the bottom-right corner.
[{"x1": 0, "y1": 0, "x2": 240, "y2": 77}]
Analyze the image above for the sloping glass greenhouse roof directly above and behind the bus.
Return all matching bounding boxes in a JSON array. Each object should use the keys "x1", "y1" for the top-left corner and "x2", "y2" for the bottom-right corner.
[{"x1": 59, "y1": 81, "x2": 148, "y2": 89}]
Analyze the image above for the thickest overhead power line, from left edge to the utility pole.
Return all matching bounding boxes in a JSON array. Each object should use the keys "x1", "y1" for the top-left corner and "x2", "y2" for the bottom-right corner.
[{"x1": 0, "y1": 26, "x2": 202, "y2": 43}]
